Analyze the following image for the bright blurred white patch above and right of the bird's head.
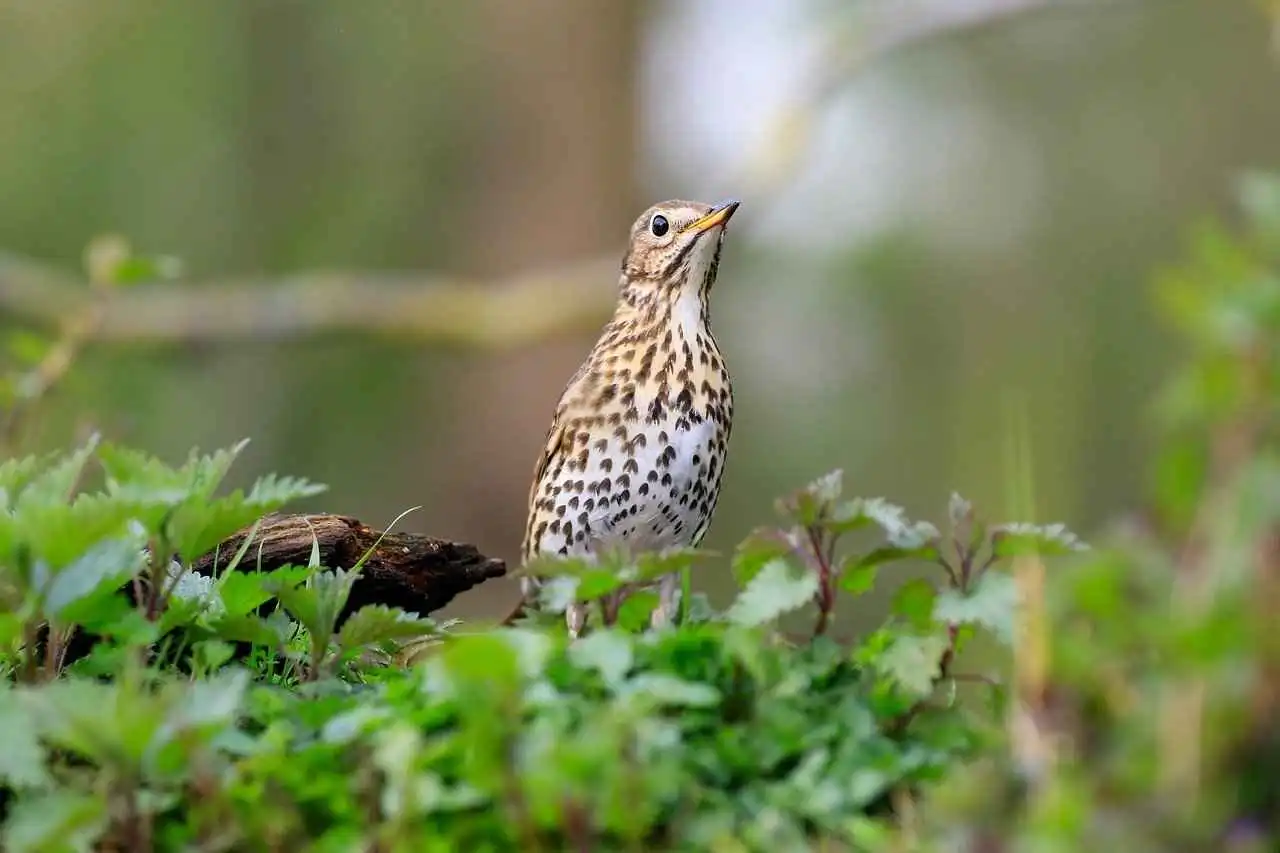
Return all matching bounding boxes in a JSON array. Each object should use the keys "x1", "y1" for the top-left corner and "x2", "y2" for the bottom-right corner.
[{"x1": 640, "y1": 0, "x2": 1043, "y2": 251}]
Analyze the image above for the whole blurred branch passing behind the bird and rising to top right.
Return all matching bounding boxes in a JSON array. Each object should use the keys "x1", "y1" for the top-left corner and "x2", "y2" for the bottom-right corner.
[{"x1": 0, "y1": 0, "x2": 1134, "y2": 348}]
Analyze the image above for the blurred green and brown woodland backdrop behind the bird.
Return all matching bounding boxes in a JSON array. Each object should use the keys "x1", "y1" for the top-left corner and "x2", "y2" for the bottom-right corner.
[{"x1": 0, "y1": 0, "x2": 1280, "y2": 613}]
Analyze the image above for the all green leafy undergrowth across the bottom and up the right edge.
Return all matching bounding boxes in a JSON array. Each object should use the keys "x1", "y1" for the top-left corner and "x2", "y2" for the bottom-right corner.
[{"x1": 0, "y1": 178, "x2": 1280, "y2": 853}]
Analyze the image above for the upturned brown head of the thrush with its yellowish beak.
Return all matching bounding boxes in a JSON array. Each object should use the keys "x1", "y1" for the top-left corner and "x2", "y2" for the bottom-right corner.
[{"x1": 622, "y1": 201, "x2": 739, "y2": 301}]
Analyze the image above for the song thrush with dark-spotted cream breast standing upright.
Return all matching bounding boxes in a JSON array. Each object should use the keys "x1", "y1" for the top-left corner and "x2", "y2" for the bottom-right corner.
[{"x1": 517, "y1": 201, "x2": 739, "y2": 637}]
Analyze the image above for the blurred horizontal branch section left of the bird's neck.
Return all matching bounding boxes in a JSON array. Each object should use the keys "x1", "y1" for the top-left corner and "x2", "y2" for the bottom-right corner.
[{"x1": 0, "y1": 254, "x2": 618, "y2": 348}]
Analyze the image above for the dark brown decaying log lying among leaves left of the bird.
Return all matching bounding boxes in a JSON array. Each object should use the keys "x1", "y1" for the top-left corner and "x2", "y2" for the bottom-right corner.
[{"x1": 192, "y1": 514, "x2": 507, "y2": 620}]
